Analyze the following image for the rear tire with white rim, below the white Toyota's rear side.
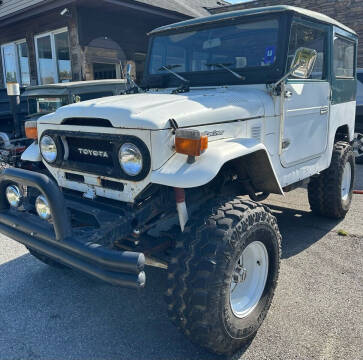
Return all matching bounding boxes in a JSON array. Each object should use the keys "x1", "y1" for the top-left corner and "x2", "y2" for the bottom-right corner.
[{"x1": 308, "y1": 141, "x2": 355, "y2": 219}]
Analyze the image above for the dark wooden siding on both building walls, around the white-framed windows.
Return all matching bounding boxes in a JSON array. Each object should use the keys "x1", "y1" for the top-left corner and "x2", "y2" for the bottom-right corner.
[{"x1": 0, "y1": 2, "x2": 182, "y2": 87}]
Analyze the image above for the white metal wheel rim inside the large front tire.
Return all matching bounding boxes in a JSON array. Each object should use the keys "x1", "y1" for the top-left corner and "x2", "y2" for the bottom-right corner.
[{"x1": 229, "y1": 241, "x2": 268, "y2": 318}]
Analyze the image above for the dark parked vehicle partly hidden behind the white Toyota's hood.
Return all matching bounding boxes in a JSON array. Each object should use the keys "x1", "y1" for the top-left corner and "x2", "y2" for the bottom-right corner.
[{"x1": 0, "y1": 79, "x2": 128, "y2": 167}]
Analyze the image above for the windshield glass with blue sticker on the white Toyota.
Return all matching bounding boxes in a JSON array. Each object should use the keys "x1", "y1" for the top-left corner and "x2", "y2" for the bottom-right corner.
[{"x1": 148, "y1": 19, "x2": 279, "y2": 78}]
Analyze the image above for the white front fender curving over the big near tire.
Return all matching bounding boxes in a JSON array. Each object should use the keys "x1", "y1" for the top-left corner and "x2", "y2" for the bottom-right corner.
[{"x1": 151, "y1": 138, "x2": 283, "y2": 194}]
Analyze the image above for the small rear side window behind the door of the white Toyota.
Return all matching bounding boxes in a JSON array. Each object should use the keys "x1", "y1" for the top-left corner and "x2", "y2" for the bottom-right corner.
[{"x1": 333, "y1": 36, "x2": 355, "y2": 79}]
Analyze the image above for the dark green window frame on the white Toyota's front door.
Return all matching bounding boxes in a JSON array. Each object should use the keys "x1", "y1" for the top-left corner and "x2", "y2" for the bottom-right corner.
[{"x1": 286, "y1": 17, "x2": 331, "y2": 83}]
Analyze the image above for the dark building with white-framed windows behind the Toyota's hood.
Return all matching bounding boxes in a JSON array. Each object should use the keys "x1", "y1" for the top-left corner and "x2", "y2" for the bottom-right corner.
[{"x1": 0, "y1": 0, "x2": 229, "y2": 88}]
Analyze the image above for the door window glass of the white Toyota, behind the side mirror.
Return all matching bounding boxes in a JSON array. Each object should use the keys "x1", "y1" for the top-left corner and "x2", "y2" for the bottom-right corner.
[{"x1": 287, "y1": 21, "x2": 326, "y2": 80}]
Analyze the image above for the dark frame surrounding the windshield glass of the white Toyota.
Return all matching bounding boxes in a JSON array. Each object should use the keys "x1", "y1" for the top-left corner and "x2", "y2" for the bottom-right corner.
[{"x1": 143, "y1": 12, "x2": 291, "y2": 88}]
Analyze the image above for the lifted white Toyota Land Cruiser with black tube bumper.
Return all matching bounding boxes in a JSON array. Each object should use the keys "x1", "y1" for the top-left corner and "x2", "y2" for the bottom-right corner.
[{"x1": 0, "y1": 6, "x2": 357, "y2": 354}]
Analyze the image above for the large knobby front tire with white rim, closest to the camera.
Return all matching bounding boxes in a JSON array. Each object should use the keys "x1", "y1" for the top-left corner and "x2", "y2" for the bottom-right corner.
[{"x1": 166, "y1": 198, "x2": 281, "y2": 354}]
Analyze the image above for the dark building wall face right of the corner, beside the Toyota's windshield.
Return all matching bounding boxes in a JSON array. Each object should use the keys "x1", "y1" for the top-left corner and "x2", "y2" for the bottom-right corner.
[{"x1": 78, "y1": 7, "x2": 179, "y2": 80}]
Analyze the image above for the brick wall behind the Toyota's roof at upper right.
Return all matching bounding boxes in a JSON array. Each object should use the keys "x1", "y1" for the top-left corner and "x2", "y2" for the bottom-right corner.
[{"x1": 213, "y1": 0, "x2": 363, "y2": 68}]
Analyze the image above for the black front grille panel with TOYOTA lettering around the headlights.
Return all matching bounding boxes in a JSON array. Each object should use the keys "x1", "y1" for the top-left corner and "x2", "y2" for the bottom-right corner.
[{"x1": 42, "y1": 130, "x2": 151, "y2": 181}]
